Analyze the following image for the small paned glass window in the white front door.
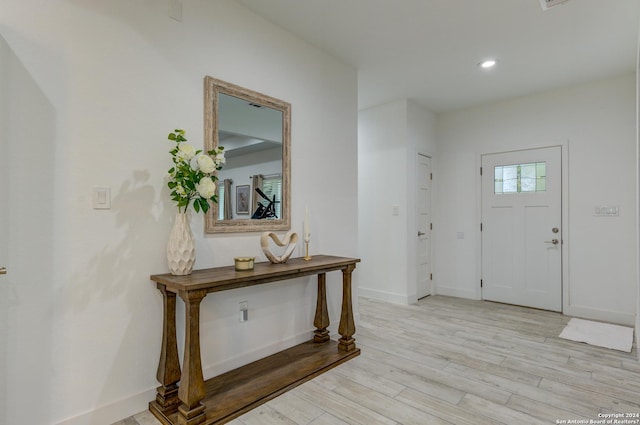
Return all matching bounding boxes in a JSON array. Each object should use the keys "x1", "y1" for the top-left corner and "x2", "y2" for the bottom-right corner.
[{"x1": 494, "y1": 162, "x2": 547, "y2": 195}]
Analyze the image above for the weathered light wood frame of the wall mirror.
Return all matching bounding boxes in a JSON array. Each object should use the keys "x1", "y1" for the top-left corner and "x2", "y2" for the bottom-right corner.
[{"x1": 204, "y1": 76, "x2": 291, "y2": 233}]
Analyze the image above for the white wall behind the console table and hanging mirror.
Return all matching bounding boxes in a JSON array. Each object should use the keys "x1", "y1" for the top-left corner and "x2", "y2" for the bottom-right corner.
[{"x1": 0, "y1": 0, "x2": 359, "y2": 425}]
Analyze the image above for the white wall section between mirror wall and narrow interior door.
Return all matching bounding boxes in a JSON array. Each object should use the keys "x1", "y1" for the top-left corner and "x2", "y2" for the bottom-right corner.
[{"x1": 358, "y1": 100, "x2": 435, "y2": 304}]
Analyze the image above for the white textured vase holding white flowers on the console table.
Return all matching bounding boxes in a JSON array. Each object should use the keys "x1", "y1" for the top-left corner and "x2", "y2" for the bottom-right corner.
[{"x1": 167, "y1": 212, "x2": 196, "y2": 276}]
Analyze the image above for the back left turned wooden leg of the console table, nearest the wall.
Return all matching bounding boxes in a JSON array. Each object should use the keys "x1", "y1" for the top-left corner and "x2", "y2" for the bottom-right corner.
[{"x1": 156, "y1": 283, "x2": 180, "y2": 415}]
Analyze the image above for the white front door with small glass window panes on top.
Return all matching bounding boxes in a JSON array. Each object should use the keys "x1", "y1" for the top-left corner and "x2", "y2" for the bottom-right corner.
[{"x1": 482, "y1": 146, "x2": 562, "y2": 311}]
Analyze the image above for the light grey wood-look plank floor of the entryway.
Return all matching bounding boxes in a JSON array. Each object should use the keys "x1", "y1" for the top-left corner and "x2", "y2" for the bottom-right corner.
[{"x1": 114, "y1": 296, "x2": 640, "y2": 425}]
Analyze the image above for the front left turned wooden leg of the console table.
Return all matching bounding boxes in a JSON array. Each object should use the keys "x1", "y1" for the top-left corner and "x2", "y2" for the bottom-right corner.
[{"x1": 177, "y1": 290, "x2": 207, "y2": 425}]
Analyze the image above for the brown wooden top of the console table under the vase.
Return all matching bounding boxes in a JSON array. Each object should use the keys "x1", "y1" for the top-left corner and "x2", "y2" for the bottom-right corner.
[{"x1": 151, "y1": 255, "x2": 360, "y2": 292}]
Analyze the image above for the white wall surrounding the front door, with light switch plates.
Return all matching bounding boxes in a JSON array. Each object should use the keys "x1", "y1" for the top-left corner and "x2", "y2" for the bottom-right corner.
[{"x1": 434, "y1": 74, "x2": 638, "y2": 324}]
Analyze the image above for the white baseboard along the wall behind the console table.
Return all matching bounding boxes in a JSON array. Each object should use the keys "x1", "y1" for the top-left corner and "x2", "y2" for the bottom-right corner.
[{"x1": 56, "y1": 331, "x2": 313, "y2": 425}]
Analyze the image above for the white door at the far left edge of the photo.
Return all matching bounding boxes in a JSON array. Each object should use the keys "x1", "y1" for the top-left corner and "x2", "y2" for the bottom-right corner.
[{"x1": 0, "y1": 35, "x2": 55, "y2": 425}]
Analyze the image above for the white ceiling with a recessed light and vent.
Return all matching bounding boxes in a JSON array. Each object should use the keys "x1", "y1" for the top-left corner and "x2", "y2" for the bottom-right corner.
[{"x1": 237, "y1": 0, "x2": 640, "y2": 112}]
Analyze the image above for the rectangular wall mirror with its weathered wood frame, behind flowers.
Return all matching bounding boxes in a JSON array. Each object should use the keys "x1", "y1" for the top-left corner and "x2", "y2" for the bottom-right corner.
[{"x1": 205, "y1": 77, "x2": 291, "y2": 233}]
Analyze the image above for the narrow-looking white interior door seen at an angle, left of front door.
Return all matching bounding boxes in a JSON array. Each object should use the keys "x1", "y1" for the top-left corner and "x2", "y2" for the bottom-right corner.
[{"x1": 416, "y1": 154, "x2": 431, "y2": 298}]
